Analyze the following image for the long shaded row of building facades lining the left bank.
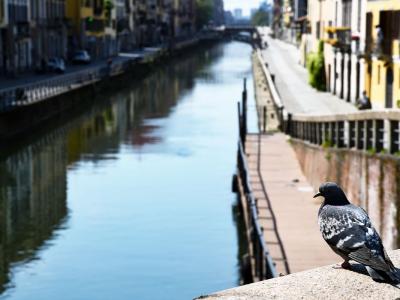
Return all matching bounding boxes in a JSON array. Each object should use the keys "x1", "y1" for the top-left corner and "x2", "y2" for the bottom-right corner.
[{"x1": 0, "y1": 0, "x2": 198, "y2": 77}]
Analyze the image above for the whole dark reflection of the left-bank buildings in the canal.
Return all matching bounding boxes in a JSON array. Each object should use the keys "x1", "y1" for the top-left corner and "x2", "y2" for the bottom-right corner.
[{"x1": 0, "y1": 42, "x2": 223, "y2": 292}]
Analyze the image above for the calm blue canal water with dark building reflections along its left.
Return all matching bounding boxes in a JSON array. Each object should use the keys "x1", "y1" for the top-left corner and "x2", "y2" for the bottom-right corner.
[{"x1": 0, "y1": 42, "x2": 255, "y2": 300}]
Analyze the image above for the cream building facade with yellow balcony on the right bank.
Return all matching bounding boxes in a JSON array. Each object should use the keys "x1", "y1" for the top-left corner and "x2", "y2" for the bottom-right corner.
[{"x1": 301, "y1": 0, "x2": 367, "y2": 103}]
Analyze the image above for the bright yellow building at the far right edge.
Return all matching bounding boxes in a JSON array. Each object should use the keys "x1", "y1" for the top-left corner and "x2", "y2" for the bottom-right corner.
[{"x1": 365, "y1": 0, "x2": 400, "y2": 108}]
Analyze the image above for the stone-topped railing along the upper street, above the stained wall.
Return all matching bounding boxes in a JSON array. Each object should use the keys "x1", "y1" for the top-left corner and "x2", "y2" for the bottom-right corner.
[{"x1": 258, "y1": 47, "x2": 400, "y2": 154}]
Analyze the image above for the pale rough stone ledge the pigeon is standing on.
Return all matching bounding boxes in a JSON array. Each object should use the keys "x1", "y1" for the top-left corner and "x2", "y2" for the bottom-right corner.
[{"x1": 198, "y1": 249, "x2": 400, "y2": 300}]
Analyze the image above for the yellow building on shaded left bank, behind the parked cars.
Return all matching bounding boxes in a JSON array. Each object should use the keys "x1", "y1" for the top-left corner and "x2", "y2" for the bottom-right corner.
[{"x1": 66, "y1": 0, "x2": 117, "y2": 59}]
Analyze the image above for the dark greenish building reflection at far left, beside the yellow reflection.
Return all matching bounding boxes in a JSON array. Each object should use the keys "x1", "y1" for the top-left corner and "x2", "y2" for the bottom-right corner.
[{"x1": 0, "y1": 139, "x2": 67, "y2": 291}]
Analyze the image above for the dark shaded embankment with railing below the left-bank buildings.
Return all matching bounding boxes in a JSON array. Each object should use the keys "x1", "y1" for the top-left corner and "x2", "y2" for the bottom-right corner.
[{"x1": 0, "y1": 33, "x2": 219, "y2": 140}]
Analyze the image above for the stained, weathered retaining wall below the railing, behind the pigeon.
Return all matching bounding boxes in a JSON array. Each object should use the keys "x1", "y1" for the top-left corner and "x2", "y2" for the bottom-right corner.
[{"x1": 291, "y1": 139, "x2": 400, "y2": 249}]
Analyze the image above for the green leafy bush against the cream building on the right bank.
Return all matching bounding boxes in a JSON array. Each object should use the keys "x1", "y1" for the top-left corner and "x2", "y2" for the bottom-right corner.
[{"x1": 307, "y1": 41, "x2": 326, "y2": 91}]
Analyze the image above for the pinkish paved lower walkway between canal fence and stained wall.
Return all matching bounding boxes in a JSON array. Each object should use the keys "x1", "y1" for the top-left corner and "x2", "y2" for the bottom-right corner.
[{"x1": 246, "y1": 133, "x2": 341, "y2": 274}]
